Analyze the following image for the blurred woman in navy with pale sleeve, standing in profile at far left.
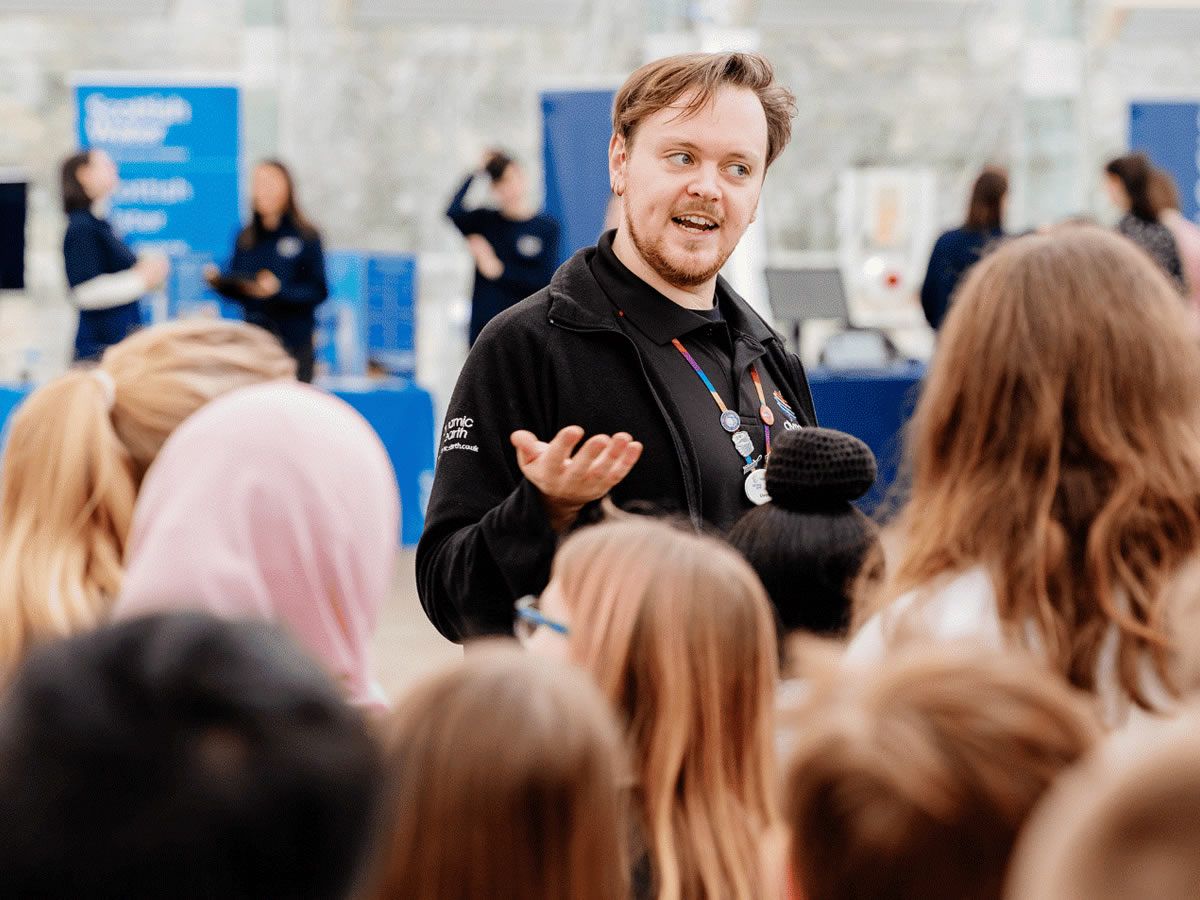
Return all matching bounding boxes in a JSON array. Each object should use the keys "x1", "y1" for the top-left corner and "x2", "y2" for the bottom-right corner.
[{"x1": 61, "y1": 150, "x2": 169, "y2": 360}]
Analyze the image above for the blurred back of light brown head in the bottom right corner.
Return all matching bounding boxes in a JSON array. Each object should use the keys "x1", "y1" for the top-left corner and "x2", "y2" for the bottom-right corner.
[{"x1": 1004, "y1": 714, "x2": 1200, "y2": 900}]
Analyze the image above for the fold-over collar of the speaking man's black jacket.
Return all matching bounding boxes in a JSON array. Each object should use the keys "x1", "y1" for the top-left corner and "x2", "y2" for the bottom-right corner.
[{"x1": 548, "y1": 234, "x2": 780, "y2": 343}]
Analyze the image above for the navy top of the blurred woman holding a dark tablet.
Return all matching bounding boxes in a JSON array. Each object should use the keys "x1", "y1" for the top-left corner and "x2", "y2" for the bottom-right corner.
[{"x1": 229, "y1": 216, "x2": 329, "y2": 350}]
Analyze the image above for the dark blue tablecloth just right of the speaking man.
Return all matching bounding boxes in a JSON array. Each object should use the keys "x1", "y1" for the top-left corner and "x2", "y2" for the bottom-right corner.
[{"x1": 808, "y1": 362, "x2": 925, "y2": 512}]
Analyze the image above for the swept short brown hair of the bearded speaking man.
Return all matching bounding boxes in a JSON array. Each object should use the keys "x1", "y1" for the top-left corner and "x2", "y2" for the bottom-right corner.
[{"x1": 612, "y1": 53, "x2": 796, "y2": 166}]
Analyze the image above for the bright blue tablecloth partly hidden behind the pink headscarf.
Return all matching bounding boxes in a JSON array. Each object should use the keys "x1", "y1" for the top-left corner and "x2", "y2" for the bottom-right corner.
[{"x1": 0, "y1": 378, "x2": 434, "y2": 546}]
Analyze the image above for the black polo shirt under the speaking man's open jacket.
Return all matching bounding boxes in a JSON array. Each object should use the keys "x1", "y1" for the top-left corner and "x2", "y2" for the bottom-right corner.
[{"x1": 590, "y1": 232, "x2": 791, "y2": 530}]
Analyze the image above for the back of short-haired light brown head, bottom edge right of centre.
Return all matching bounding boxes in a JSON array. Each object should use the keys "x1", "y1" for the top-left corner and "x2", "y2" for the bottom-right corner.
[{"x1": 785, "y1": 647, "x2": 1099, "y2": 900}]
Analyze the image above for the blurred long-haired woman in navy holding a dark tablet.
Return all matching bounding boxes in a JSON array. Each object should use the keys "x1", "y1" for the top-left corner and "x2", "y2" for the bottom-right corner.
[{"x1": 205, "y1": 160, "x2": 329, "y2": 382}]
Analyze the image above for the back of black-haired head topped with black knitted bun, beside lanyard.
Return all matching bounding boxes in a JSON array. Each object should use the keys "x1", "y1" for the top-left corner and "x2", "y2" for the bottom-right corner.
[{"x1": 728, "y1": 428, "x2": 878, "y2": 637}]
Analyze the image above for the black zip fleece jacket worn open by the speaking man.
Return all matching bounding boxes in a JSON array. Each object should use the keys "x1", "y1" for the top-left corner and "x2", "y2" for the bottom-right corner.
[{"x1": 416, "y1": 235, "x2": 816, "y2": 641}]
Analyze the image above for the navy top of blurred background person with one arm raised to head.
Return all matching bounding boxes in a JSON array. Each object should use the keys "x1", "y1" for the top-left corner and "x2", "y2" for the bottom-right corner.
[{"x1": 446, "y1": 175, "x2": 559, "y2": 343}]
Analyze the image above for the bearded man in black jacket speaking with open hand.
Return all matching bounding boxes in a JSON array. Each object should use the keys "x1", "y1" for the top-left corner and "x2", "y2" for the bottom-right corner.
[{"x1": 416, "y1": 53, "x2": 816, "y2": 641}]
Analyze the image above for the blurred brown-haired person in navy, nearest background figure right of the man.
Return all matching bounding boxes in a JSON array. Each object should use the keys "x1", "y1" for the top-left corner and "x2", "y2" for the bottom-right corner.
[{"x1": 920, "y1": 167, "x2": 1008, "y2": 331}]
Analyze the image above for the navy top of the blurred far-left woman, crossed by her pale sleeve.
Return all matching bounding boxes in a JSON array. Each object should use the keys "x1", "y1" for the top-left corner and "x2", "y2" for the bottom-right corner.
[{"x1": 62, "y1": 209, "x2": 142, "y2": 359}]
